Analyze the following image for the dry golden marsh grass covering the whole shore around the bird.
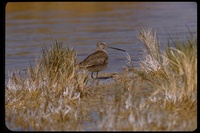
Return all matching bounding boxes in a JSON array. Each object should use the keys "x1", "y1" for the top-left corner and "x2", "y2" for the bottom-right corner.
[{"x1": 5, "y1": 29, "x2": 197, "y2": 131}]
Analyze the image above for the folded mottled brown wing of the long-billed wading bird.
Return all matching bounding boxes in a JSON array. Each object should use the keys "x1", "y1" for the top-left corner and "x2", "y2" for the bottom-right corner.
[{"x1": 80, "y1": 50, "x2": 108, "y2": 67}]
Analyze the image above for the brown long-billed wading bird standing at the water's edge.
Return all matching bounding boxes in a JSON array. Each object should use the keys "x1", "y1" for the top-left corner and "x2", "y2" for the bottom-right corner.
[{"x1": 79, "y1": 42, "x2": 126, "y2": 78}]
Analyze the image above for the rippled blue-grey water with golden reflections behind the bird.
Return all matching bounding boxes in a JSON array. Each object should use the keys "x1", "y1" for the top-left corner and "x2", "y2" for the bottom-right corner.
[{"x1": 5, "y1": 2, "x2": 197, "y2": 80}]
